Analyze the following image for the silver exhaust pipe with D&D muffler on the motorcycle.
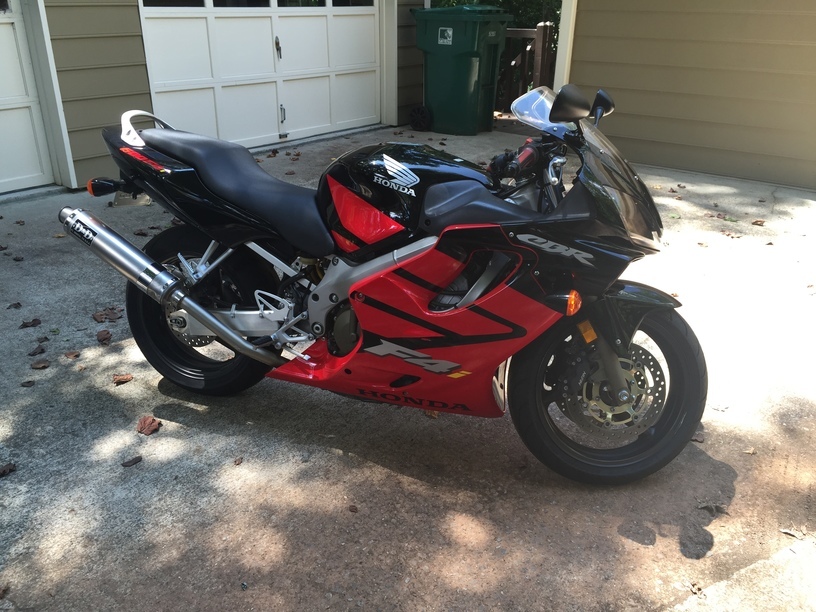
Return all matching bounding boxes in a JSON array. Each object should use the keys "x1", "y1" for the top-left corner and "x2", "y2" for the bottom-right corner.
[{"x1": 59, "y1": 206, "x2": 287, "y2": 367}]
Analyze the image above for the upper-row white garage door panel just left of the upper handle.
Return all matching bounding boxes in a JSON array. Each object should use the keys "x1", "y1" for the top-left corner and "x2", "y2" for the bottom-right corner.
[{"x1": 215, "y1": 17, "x2": 275, "y2": 79}]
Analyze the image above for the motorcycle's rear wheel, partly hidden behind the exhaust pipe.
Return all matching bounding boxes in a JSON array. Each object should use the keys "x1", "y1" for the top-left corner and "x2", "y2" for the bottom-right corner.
[{"x1": 125, "y1": 225, "x2": 278, "y2": 395}]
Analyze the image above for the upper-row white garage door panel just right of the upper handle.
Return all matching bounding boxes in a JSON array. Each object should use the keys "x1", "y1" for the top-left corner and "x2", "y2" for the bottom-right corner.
[{"x1": 276, "y1": 15, "x2": 329, "y2": 73}]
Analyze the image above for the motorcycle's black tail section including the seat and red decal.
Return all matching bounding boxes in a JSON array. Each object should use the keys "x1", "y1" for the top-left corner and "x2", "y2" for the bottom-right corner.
[{"x1": 103, "y1": 128, "x2": 334, "y2": 257}]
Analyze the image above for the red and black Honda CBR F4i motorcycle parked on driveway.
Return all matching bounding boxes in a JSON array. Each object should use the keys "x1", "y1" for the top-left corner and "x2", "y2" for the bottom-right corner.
[{"x1": 59, "y1": 85, "x2": 707, "y2": 484}]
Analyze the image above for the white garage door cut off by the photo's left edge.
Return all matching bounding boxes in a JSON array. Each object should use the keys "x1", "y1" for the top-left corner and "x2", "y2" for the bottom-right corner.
[{"x1": 0, "y1": 0, "x2": 54, "y2": 193}]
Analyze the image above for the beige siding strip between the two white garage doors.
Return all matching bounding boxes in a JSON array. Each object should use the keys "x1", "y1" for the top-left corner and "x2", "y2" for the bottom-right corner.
[{"x1": 45, "y1": 0, "x2": 152, "y2": 185}]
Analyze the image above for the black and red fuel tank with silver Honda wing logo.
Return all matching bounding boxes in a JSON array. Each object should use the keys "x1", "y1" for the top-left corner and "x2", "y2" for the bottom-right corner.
[{"x1": 317, "y1": 143, "x2": 499, "y2": 261}]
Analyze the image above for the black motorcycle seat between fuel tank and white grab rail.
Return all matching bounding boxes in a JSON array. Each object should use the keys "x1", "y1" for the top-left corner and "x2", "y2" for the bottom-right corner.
[{"x1": 140, "y1": 128, "x2": 334, "y2": 257}]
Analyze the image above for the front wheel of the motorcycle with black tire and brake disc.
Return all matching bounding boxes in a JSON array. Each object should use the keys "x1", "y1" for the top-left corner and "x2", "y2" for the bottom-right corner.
[{"x1": 508, "y1": 310, "x2": 708, "y2": 484}]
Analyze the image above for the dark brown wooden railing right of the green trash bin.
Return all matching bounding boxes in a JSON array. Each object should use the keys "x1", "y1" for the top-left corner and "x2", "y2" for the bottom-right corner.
[{"x1": 496, "y1": 21, "x2": 556, "y2": 111}]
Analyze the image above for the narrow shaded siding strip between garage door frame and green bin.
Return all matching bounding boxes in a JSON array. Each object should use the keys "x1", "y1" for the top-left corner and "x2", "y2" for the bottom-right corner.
[{"x1": 397, "y1": 0, "x2": 425, "y2": 125}]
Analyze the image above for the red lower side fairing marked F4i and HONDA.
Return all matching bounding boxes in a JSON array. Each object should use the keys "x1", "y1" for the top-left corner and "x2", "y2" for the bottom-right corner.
[{"x1": 269, "y1": 227, "x2": 562, "y2": 417}]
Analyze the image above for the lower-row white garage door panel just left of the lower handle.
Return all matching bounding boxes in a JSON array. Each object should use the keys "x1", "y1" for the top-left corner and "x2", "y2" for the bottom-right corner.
[{"x1": 218, "y1": 83, "x2": 278, "y2": 147}]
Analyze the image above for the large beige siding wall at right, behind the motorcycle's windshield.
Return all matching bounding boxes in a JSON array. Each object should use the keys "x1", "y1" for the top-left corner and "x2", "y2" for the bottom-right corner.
[{"x1": 570, "y1": 0, "x2": 816, "y2": 188}]
